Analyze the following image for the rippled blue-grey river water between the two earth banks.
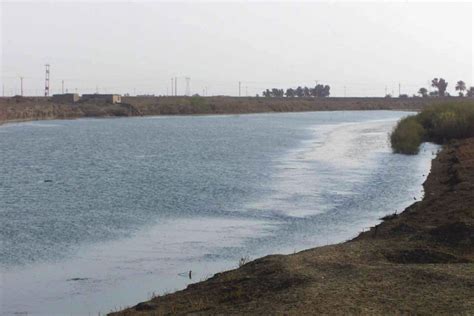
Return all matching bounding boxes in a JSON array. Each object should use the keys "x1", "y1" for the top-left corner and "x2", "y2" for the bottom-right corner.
[{"x1": 0, "y1": 111, "x2": 436, "y2": 315}]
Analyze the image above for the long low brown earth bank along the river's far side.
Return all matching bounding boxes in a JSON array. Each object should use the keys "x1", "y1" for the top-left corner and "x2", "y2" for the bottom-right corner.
[{"x1": 0, "y1": 96, "x2": 461, "y2": 123}]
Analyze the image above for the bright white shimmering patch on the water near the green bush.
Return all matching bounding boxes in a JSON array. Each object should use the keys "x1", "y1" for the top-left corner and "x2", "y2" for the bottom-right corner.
[{"x1": 248, "y1": 118, "x2": 398, "y2": 217}]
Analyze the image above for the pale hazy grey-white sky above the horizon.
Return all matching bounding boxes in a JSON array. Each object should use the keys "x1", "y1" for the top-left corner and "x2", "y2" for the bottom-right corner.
[{"x1": 0, "y1": 1, "x2": 474, "y2": 96}]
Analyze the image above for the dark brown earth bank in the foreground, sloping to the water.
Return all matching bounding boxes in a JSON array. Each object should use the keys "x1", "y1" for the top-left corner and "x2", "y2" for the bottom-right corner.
[{"x1": 110, "y1": 138, "x2": 474, "y2": 315}]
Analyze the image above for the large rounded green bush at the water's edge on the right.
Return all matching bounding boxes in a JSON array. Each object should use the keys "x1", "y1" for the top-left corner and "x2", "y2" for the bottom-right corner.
[{"x1": 390, "y1": 101, "x2": 474, "y2": 155}]
